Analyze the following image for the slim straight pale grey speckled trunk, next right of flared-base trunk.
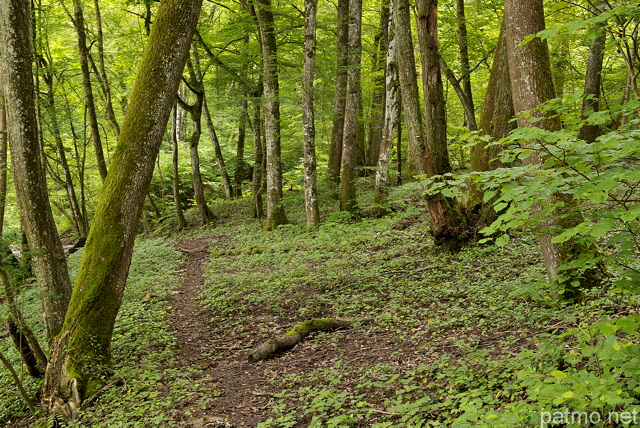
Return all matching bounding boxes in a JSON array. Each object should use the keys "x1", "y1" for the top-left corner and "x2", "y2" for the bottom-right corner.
[{"x1": 302, "y1": 0, "x2": 320, "y2": 228}]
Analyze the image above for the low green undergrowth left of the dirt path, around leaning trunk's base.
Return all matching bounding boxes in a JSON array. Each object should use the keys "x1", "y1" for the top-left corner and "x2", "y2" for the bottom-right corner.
[{"x1": 0, "y1": 238, "x2": 212, "y2": 427}]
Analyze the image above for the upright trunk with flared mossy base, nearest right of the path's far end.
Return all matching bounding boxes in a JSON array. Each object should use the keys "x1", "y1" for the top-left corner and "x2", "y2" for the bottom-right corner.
[{"x1": 255, "y1": 0, "x2": 287, "y2": 230}]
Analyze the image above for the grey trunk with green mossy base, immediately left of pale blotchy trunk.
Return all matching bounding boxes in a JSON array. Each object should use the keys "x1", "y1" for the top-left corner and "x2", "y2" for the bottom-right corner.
[{"x1": 340, "y1": 0, "x2": 362, "y2": 213}]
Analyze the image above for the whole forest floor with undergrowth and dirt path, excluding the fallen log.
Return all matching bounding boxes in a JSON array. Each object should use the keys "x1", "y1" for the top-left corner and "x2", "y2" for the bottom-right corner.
[{"x1": 0, "y1": 186, "x2": 640, "y2": 428}]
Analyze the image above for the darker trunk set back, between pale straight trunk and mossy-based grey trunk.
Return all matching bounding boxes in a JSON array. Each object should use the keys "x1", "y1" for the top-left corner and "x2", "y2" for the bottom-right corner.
[{"x1": 328, "y1": 0, "x2": 349, "y2": 191}]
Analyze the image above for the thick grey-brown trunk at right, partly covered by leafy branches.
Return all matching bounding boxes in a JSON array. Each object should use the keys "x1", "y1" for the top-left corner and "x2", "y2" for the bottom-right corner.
[{"x1": 505, "y1": 0, "x2": 602, "y2": 298}]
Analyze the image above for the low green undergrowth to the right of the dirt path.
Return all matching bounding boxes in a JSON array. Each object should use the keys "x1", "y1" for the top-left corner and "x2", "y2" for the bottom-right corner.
[{"x1": 202, "y1": 186, "x2": 640, "y2": 428}]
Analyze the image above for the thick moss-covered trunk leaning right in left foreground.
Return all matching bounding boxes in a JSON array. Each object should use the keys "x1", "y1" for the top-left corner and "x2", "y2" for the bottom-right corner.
[{"x1": 42, "y1": 0, "x2": 202, "y2": 416}]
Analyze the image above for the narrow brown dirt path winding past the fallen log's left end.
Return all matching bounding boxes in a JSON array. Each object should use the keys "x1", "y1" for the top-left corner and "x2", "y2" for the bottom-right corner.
[{"x1": 169, "y1": 236, "x2": 267, "y2": 427}]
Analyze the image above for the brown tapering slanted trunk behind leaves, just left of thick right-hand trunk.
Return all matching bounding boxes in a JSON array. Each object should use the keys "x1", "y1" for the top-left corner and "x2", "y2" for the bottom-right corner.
[{"x1": 467, "y1": 20, "x2": 516, "y2": 228}]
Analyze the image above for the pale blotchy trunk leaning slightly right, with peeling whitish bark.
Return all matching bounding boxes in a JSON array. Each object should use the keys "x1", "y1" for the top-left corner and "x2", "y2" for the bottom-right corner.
[{"x1": 375, "y1": 0, "x2": 400, "y2": 214}]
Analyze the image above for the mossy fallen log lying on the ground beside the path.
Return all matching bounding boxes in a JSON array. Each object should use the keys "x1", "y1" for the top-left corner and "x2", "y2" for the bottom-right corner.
[{"x1": 248, "y1": 318, "x2": 373, "y2": 363}]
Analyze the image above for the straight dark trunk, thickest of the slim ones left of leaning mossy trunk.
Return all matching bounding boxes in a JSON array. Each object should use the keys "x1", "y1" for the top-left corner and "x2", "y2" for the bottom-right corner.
[{"x1": 73, "y1": 0, "x2": 107, "y2": 182}]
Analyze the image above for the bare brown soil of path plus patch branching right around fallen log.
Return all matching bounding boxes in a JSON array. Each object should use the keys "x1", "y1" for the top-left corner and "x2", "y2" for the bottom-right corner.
[{"x1": 168, "y1": 236, "x2": 416, "y2": 427}]
